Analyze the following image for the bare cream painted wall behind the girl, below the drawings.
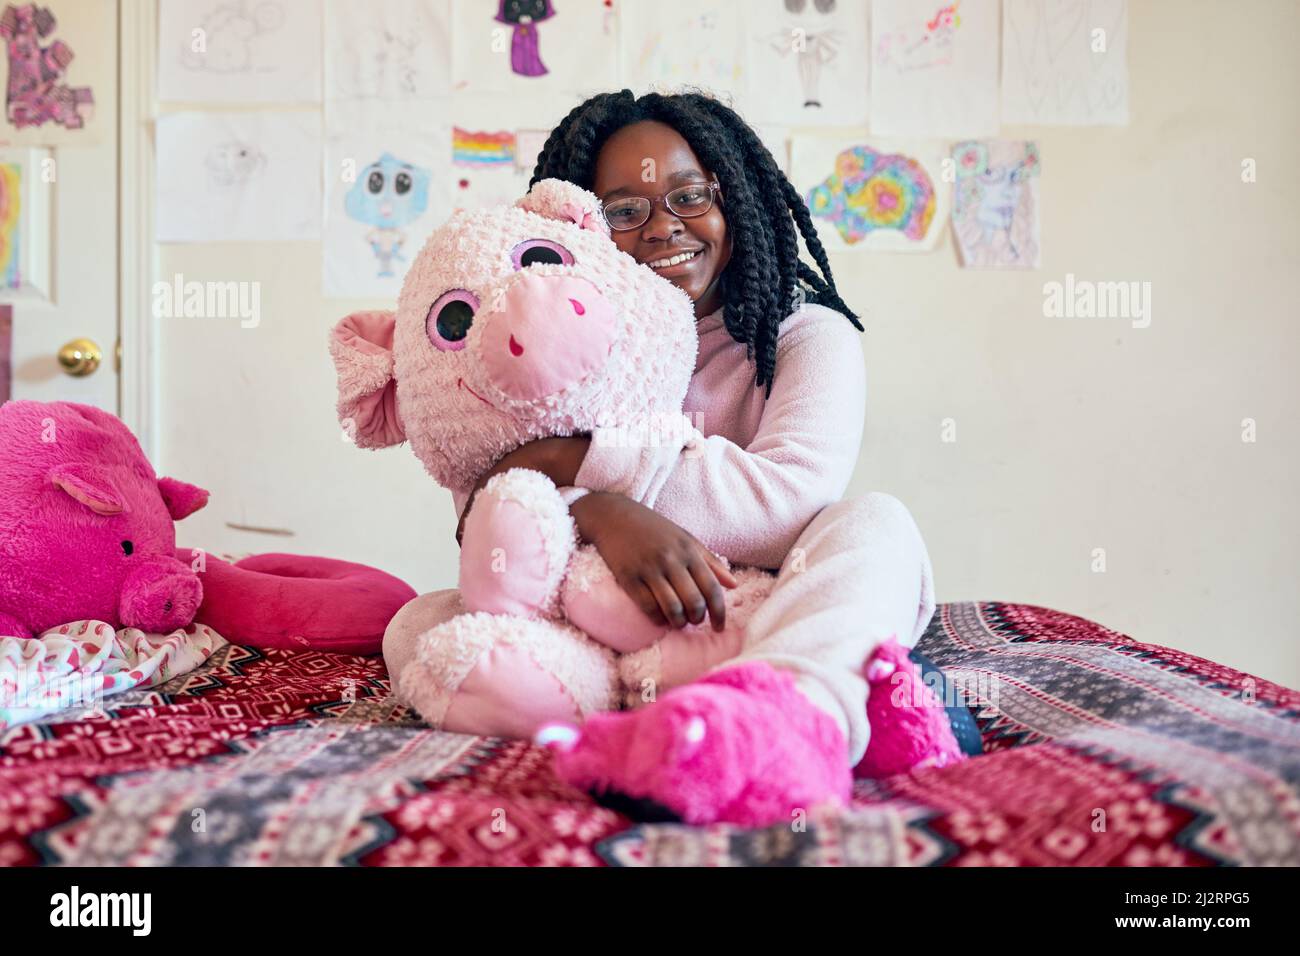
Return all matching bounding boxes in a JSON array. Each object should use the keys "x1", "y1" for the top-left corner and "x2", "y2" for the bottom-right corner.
[{"x1": 149, "y1": 0, "x2": 1300, "y2": 687}]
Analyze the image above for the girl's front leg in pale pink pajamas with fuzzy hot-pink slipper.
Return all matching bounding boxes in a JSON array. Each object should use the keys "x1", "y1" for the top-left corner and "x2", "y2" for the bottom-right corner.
[{"x1": 540, "y1": 494, "x2": 935, "y2": 826}]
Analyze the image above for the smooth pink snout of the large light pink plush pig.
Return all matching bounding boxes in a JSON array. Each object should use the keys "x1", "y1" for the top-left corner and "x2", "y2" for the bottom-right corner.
[{"x1": 482, "y1": 273, "x2": 616, "y2": 402}]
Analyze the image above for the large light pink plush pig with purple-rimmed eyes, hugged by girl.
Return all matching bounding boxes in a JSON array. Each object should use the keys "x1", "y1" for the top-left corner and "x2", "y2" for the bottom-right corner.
[{"x1": 330, "y1": 179, "x2": 772, "y2": 732}]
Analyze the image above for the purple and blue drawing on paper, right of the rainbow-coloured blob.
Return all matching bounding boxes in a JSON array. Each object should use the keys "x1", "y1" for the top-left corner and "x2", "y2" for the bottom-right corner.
[{"x1": 953, "y1": 140, "x2": 1041, "y2": 269}]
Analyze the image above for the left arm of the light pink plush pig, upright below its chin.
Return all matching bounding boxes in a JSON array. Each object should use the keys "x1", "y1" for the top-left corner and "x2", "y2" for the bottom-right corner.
[{"x1": 460, "y1": 468, "x2": 576, "y2": 618}]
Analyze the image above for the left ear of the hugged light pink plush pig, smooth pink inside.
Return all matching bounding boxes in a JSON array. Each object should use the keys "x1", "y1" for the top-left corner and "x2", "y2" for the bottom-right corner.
[{"x1": 329, "y1": 312, "x2": 406, "y2": 449}]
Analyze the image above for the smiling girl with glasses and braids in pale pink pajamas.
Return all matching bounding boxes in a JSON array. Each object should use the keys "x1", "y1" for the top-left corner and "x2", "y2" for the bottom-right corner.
[{"x1": 384, "y1": 90, "x2": 935, "y2": 822}]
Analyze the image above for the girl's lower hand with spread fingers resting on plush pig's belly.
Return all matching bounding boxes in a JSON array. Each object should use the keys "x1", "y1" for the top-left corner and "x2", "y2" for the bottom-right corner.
[{"x1": 569, "y1": 492, "x2": 736, "y2": 631}]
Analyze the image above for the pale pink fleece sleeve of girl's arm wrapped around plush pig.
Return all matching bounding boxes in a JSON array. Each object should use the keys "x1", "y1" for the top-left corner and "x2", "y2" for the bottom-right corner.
[{"x1": 575, "y1": 307, "x2": 866, "y2": 567}]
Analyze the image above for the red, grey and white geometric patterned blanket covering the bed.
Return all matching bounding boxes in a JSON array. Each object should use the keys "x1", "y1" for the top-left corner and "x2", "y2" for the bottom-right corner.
[{"x1": 0, "y1": 602, "x2": 1300, "y2": 866}]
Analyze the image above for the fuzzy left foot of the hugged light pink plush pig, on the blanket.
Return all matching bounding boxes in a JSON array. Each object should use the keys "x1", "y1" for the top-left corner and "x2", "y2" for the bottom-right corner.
[{"x1": 384, "y1": 591, "x2": 616, "y2": 737}]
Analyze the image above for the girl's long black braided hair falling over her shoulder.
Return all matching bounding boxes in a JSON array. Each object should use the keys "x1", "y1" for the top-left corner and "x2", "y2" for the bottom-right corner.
[{"x1": 529, "y1": 90, "x2": 862, "y2": 395}]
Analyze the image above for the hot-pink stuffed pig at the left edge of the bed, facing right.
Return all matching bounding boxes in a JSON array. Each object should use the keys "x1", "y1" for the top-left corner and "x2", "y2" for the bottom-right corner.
[{"x1": 0, "y1": 402, "x2": 208, "y2": 637}]
